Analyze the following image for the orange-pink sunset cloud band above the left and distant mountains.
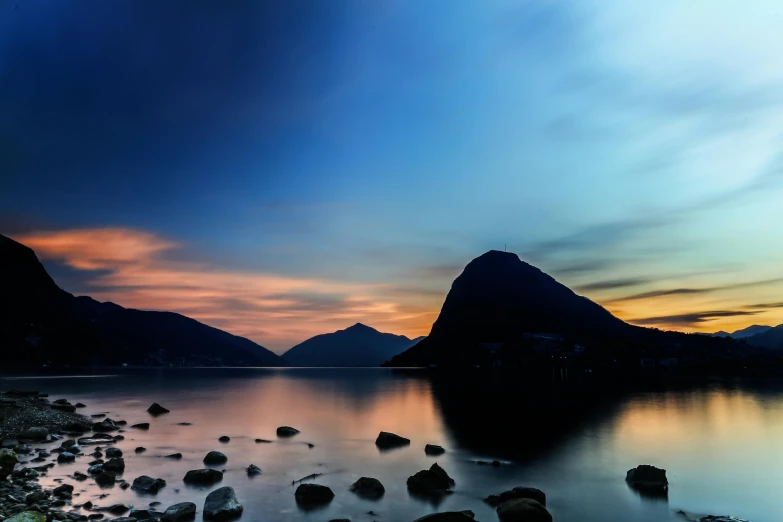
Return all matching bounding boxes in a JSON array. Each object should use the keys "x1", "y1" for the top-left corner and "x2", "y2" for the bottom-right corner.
[{"x1": 15, "y1": 228, "x2": 441, "y2": 352}]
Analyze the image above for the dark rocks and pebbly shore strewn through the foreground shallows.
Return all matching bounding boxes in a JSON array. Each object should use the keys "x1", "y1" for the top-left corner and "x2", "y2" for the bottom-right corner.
[{"x1": 0, "y1": 390, "x2": 747, "y2": 522}]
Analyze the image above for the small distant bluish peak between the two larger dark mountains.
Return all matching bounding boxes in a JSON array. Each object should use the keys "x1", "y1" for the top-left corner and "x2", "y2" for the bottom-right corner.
[{"x1": 283, "y1": 323, "x2": 423, "y2": 366}]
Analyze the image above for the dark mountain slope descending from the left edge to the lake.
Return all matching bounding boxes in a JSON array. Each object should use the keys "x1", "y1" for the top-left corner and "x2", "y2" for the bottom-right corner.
[{"x1": 0, "y1": 235, "x2": 286, "y2": 366}]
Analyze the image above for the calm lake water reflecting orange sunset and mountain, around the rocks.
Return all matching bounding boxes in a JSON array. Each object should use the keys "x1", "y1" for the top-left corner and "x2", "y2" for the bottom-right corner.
[{"x1": 0, "y1": 369, "x2": 783, "y2": 522}]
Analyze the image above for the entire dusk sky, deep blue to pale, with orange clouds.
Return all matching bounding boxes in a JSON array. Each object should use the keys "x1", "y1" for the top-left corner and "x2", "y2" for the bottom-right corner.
[{"x1": 0, "y1": 0, "x2": 783, "y2": 352}]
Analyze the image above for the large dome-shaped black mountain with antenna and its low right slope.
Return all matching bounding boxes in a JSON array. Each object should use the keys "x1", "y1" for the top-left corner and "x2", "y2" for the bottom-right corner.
[{"x1": 388, "y1": 250, "x2": 738, "y2": 368}]
